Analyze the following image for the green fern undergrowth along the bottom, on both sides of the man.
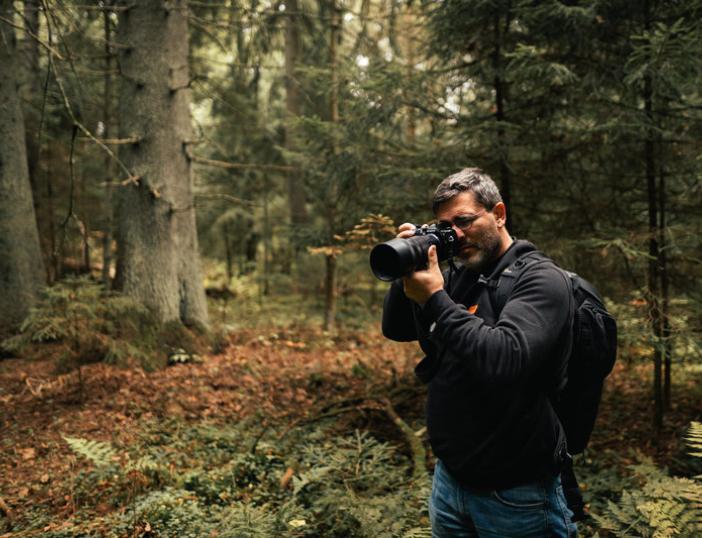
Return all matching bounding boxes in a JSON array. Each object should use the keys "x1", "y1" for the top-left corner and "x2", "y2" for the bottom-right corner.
[{"x1": 8, "y1": 410, "x2": 702, "y2": 538}]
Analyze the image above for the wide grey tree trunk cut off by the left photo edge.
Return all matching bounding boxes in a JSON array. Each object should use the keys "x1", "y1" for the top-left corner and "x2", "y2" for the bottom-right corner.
[{"x1": 0, "y1": 0, "x2": 44, "y2": 328}]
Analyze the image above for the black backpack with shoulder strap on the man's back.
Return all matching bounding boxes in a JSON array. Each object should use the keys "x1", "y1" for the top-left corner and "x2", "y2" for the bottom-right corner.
[{"x1": 489, "y1": 251, "x2": 617, "y2": 454}]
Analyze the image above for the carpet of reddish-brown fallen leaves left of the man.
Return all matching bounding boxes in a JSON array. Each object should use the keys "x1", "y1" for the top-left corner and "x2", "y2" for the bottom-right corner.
[{"x1": 0, "y1": 328, "x2": 416, "y2": 528}]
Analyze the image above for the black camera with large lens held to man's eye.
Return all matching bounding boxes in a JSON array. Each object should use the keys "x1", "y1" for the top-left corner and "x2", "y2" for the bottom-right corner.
[{"x1": 370, "y1": 224, "x2": 458, "y2": 281}]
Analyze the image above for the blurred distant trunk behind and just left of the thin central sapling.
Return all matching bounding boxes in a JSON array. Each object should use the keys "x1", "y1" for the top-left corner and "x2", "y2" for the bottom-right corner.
[{"x1": 285, "y1": 0, "x2": 307, "y2": 225}]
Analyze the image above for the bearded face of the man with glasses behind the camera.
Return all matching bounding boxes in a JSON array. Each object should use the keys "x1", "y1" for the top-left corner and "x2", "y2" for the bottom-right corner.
[{"x1": 436, "y1": 191, "x2": 501, "y2": 271}]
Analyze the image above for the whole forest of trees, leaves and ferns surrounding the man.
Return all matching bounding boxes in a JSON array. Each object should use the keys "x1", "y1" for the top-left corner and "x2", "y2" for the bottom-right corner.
[{"x1": 0, "y1": 0, "x2": 702, "y2": 537}]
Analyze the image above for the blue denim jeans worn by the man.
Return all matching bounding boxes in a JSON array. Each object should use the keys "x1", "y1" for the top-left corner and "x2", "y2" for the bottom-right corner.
[{"x1": 429, "y1": 460, "x2": 577, "y2": 538}]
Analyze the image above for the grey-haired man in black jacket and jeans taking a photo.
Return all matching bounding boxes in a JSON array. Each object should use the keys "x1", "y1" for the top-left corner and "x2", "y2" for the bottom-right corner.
[{"x1": 383, "y1": 168, "x2": 576, "y2": 538}]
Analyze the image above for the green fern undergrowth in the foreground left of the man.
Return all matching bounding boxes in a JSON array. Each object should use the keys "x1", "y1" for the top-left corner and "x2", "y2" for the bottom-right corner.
[{"x1": 13, "y1": 414, "x2": 430, "y2": 538}]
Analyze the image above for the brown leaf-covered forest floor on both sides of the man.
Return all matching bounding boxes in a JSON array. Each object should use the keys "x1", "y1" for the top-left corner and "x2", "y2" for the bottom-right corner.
[{"x1": 0, "y1": 322, "x2": 702, "y2": 538}]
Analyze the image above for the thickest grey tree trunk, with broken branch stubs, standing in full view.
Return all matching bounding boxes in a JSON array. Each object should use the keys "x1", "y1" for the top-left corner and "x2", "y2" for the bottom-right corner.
[{"x1": 117, "y1": 0, "x2": 207, "y2": 326}]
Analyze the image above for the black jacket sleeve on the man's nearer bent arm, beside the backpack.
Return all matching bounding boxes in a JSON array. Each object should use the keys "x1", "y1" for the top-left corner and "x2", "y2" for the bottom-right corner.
[{"x1": 424, "y1": 265, "x2": 573, "y2": 385}]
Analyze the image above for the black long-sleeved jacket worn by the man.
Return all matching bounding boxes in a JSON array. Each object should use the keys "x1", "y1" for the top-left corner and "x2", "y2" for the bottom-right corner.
[{"x1": 383, "y1": 241, "x2": 573, "y2": 489}]
